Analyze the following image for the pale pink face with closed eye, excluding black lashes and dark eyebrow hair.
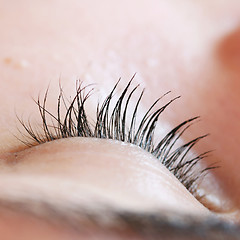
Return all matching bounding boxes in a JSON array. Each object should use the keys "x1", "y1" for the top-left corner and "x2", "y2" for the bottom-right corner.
[{"x1": 0, "y1": 0, "x2": 240, "y2": 240}]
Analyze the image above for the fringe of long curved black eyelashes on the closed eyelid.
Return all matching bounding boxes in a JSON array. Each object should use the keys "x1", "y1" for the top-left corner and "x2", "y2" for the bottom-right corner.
[{"x1": 18, "y1": 78, "x2": 215, "y2": 197}]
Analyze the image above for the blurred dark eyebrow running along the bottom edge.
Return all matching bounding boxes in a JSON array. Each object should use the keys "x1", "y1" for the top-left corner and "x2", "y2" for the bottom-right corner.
[{"x1": 0, "y1": 196, "x2": 240, "y2": 240}]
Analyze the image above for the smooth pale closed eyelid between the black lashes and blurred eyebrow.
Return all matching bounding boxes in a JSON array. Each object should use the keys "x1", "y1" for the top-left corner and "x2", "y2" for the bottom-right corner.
[{"x1": 1, "y1": 138, "x2": 210, "y2": 215}]
